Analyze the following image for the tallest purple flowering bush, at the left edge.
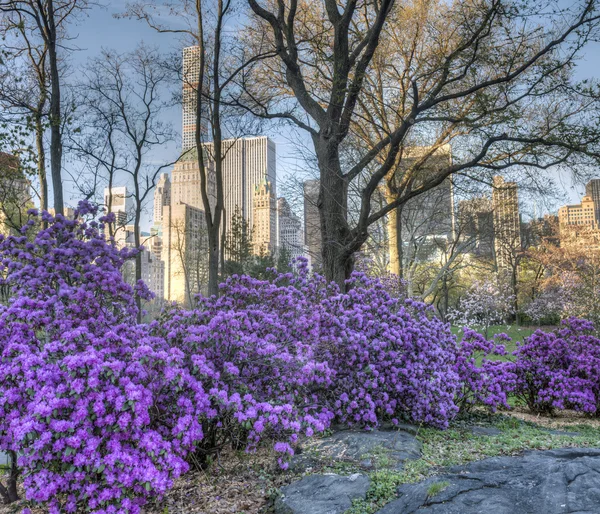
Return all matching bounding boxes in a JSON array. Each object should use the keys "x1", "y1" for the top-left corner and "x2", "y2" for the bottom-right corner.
[{"x1": 0, "y1": 204, "x2": 207, "y2": 513}]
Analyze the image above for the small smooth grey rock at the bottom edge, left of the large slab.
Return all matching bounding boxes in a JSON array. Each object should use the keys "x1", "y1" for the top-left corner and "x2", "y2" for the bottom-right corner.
[{"x1": 274, "y1": 473, "x2": 369, "y2": 514}]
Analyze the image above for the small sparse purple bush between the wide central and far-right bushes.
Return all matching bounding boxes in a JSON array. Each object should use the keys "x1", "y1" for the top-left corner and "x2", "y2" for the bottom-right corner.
[{"x1": 455, "y1": 327, "x2": 516, "y2": 412}]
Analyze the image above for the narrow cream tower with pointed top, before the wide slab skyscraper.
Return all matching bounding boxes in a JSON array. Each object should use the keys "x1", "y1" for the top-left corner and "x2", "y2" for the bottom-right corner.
[{"x1": 252, "y1": 180, "x2": 277, "y2": 255}]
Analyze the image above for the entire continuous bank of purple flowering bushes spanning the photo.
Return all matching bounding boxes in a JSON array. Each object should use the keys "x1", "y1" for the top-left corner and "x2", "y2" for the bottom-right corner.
[{"x1": 10, "y1": 203, "x2": 600, "y2": 508}]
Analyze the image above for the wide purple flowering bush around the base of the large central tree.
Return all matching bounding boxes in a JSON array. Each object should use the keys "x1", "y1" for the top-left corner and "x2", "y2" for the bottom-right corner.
[{"x1": 190, "y1": 261, "x2": 458, "y2": 433}]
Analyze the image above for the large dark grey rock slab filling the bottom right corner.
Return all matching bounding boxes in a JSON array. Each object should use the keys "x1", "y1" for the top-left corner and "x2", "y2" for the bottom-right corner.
[{"x1": 378, "y1": 448, "x2": 600, "y2": 514}]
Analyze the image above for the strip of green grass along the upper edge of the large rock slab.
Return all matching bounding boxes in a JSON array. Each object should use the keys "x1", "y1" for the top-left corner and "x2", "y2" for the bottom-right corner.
[{"x1": 346, "y1": 414, "x2": 600, "y2": 514}]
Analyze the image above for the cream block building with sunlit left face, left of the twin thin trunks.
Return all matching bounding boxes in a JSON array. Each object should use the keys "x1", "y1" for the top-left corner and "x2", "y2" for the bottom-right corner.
[{"x1": 161, "y1": 203, "x2": 208, "y2": 306}]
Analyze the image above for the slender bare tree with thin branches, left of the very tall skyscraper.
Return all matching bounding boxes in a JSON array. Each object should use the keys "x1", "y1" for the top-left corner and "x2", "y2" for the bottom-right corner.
[{"x1": 74, "y1": 46, "x2": 174, "y2": 316}]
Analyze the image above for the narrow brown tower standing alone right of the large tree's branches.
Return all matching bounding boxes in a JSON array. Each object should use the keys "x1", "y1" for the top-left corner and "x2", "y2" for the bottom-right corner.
[{"x1": 492, "y1": 175, "x2": 521, "y2": 270}]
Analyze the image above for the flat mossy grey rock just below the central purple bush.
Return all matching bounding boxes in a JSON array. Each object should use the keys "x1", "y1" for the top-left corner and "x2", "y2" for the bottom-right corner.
[{"x1": 291, "y1": 430, "x2": 421, "y2": 471}]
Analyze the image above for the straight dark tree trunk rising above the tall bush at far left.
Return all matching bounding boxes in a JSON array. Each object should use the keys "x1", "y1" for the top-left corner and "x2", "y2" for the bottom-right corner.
[{"x1": 48, "y1": 5, "x2": 64, "y2": 214}]
